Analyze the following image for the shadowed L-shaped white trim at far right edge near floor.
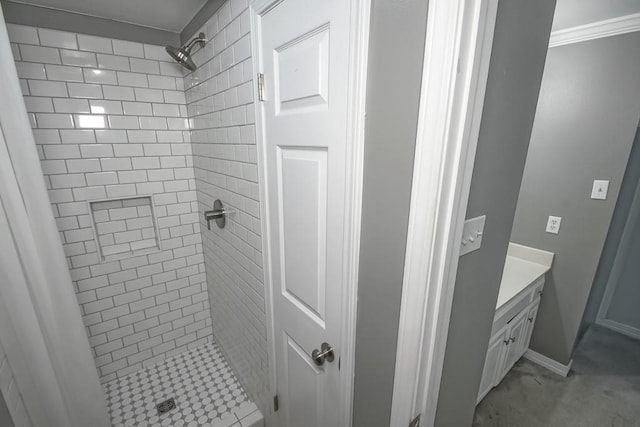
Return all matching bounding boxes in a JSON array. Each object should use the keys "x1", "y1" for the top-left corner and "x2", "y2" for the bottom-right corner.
[{"x1": 596, "y1": 171, "x2": 640, "y2": 338}]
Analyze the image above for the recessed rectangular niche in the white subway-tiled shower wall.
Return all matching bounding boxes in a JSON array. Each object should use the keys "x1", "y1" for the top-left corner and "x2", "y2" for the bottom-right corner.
[{"x1": 90, "y1": 196, "x2": 160, "y2": 261}]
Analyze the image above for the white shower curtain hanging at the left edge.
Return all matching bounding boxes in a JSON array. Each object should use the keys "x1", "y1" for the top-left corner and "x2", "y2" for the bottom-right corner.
[{"x1": 0, "y1": 10, "x2": 110, "y2": 427}]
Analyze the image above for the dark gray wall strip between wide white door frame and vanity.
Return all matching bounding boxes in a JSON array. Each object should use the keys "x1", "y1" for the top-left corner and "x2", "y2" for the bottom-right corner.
[{"x1": 436, "y1": 0, "x2": 555, "y2": 426}]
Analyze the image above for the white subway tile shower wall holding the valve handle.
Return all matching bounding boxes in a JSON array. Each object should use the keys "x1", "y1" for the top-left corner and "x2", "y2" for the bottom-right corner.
[{"x1": 184, "y1": 0, "x2": 271, "y2": 414}]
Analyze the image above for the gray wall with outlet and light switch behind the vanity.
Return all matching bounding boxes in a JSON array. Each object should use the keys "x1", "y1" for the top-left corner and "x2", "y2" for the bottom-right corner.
[{"x1": 511, "y1": 33, "x2": 640, "y2": 364}]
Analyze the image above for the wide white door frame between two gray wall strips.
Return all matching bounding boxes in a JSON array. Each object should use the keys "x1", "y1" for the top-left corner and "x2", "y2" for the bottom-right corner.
[{"x1": 391, "y1": 0, "x2": 498, "y2": 427}]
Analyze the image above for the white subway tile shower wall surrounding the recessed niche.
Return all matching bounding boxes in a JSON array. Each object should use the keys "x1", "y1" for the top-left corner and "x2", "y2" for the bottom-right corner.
[{"x1": 8, "y1": 25, "x2": 212, "y2": 382}]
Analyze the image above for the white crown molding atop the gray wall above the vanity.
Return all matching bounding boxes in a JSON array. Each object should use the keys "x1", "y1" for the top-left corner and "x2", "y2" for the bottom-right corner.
[{"x1": 549, "y1": 13, "x2": 640, "y2": 48}]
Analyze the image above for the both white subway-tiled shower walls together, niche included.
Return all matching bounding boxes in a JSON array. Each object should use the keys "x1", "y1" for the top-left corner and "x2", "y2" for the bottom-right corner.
[{"x1": 8, "y1": 0, "x2": 270, "y2": 424}]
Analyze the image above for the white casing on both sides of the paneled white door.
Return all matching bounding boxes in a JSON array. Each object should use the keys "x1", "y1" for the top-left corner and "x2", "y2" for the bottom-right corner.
[{"x1": 249, "y1": 0, "x2": 371, "y2": 426}]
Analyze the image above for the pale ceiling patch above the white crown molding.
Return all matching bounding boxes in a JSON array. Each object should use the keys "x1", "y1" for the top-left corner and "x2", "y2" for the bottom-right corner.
[{"x1": 553, "y1": 0, "x2": 640, "y2": 31}]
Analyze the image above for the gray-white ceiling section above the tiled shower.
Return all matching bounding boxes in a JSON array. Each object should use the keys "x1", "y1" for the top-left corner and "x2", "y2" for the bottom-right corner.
[{"x1": 10, "y1": 0, "x2": 207, "y2": 33}]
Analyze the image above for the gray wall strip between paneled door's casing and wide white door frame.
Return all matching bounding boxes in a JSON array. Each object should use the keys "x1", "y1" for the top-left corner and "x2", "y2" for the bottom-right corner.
[{"x1": 353, "y1": 0, "x2": 427, "y2": 427}]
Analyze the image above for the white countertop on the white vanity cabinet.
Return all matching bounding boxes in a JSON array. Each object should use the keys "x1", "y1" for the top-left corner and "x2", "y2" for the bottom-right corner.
[{"x1": 496, "y1": 243, "x2": 554, "y2": 310}]
